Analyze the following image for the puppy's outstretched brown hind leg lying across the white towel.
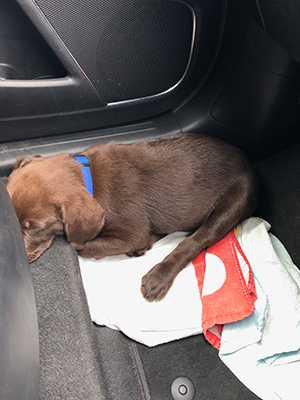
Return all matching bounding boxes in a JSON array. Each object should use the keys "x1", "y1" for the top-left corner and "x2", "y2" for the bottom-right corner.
[{"x1": 141, "y1": 170, "x2": 258, "y2": 301}]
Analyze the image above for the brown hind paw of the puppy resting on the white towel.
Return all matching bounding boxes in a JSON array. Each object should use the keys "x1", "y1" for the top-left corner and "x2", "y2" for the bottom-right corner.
[{"x1": 141, "y1": 265, "x2": 173, "y2": 301}]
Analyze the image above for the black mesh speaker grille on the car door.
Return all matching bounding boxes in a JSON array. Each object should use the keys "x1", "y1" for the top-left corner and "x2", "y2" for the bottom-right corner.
[{"x1": 32, "y1": 0, "x2": 193, "y2": 102}]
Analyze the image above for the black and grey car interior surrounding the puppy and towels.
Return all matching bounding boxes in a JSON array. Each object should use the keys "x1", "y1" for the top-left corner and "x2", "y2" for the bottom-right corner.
[{"x1": 0, "y1": 0, "x2": 300, "y2": 400}]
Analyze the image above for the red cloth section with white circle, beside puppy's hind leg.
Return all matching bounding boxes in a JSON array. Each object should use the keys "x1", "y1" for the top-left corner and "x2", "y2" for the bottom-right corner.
[{"x1": 193, "y1": 230, "x2": 257, "y2": 349}]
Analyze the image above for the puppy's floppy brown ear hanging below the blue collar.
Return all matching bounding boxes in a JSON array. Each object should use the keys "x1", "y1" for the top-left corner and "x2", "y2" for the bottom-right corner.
[{"x1": 61, "y1": 189, "x2": 105, "y2": 250}]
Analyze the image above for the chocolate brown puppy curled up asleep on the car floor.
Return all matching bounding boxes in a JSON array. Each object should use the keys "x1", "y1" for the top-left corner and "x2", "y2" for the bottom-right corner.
[{"x1": 7, "y1": 134, "x2": 258, "y2": 301}]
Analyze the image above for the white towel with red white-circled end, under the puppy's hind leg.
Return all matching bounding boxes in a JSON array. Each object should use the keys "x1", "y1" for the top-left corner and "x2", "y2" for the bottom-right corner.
[{"x1": 79, "y1": 225, "x2": 256, "y2": 348}]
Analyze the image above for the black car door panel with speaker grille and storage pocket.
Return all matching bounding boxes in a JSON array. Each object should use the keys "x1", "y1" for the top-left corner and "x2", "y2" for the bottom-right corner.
[{"x1": 0, "y1": 0, "x2": 227, "y2": 140}]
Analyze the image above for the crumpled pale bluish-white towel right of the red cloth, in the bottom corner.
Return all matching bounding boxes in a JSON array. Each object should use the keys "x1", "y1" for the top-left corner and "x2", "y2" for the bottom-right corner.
[{"x1": 219, "y1": 218, "x2": 300, "y2": 400}]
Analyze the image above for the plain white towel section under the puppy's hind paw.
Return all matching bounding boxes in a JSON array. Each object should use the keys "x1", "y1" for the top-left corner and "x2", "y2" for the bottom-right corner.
[{"x1": 79, "y1": 232, "x2": 202, "y2": 346}]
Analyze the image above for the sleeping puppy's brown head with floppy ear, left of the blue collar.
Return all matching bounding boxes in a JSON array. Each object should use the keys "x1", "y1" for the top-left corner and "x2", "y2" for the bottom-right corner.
[{"x1": 6, "y1": 154, "x2": 104, "y2": 262}]
